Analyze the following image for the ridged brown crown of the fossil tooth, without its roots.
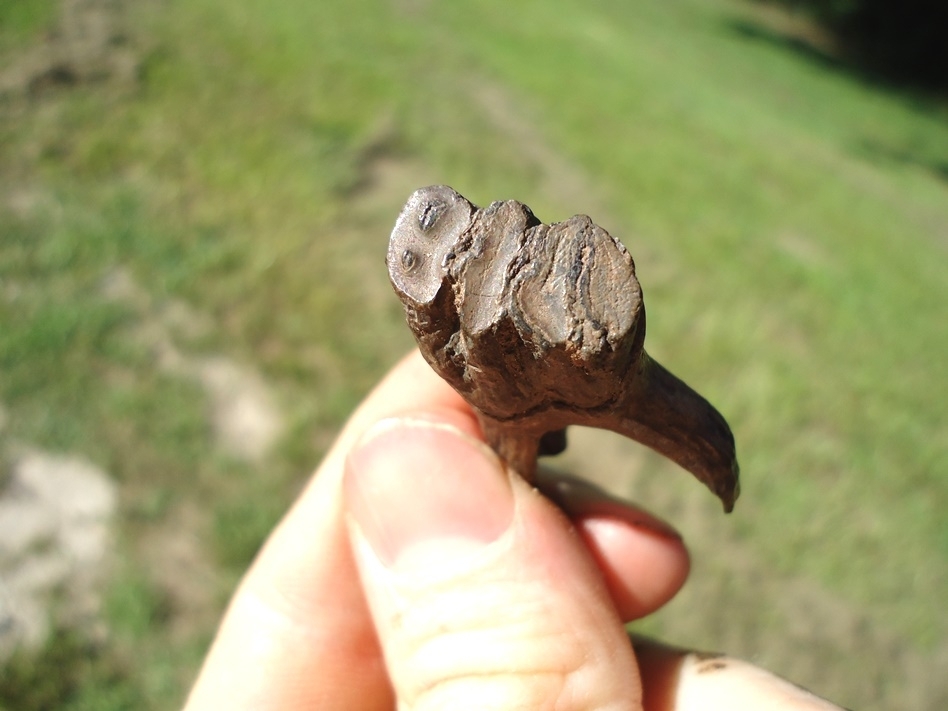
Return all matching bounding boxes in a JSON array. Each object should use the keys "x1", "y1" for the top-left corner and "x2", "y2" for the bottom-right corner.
[{"x1": 388, "y1": 186, "x2": 645, "y2": 419}]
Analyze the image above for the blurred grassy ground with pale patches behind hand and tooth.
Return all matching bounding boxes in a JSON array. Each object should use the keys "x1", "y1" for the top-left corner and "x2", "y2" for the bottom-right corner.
[{"x1": 0, "y1": 0, "x2": 948, "y2": 711}]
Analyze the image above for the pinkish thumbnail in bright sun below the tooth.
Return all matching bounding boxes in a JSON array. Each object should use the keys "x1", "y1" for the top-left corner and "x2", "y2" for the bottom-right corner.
[{"x1": 344, "y1": 418, "x2": 514, "y2": 568}]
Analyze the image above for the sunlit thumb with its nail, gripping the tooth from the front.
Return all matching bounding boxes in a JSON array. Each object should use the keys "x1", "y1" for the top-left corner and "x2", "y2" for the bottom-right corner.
[{"x1": 345, "y1": 417, "x2": 641, "y2": 710}]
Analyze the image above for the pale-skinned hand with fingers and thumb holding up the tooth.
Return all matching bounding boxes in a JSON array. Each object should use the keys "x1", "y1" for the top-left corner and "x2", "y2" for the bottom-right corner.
[{"x1": 185, "y1": 353, "x2": 838, "y2": 711}]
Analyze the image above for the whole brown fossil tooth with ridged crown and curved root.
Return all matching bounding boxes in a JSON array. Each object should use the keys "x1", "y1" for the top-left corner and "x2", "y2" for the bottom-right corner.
[{"x1": 388, "y1": 186, "x2": 739, "y2": 511}]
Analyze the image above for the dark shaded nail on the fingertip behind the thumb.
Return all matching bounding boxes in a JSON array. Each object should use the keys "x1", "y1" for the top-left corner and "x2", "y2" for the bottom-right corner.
[{"x1": 538, "y1": 475, "x2": 681, "y2": 541}]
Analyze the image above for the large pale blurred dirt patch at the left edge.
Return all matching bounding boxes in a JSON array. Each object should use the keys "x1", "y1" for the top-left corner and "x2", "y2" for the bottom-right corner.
[{"x1": 0, "y1": 451, "x2": 116, "y2": 658}]
